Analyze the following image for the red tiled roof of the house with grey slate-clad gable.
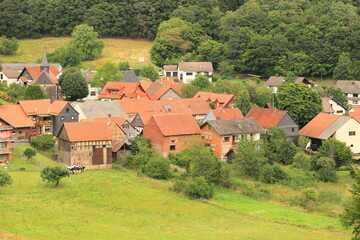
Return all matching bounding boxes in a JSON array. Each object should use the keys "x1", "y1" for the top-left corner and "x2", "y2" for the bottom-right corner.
[{"x1": 246, "y1": 108, "x2": 287, "y2": 128}]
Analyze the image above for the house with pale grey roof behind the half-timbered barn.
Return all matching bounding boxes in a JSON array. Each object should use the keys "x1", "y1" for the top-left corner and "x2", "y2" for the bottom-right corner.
[{"x1": 71, "y1": 100, "x2": 129, "y2": 121}]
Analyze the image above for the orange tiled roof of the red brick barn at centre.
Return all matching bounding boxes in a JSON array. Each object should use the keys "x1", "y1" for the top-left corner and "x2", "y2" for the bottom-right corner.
[{"x1": 152, "y1": 114, "x2": 201, "y2": 136}]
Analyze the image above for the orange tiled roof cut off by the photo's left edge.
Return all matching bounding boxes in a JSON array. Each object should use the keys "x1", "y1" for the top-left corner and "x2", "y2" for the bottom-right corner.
[{"x1": 0, "y1": 105, "x2": 34, "y2": 128}]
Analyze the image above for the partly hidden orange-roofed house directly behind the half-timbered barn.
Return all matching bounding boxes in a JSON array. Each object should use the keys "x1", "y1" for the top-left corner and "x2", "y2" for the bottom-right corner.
[{"x1": 81, "y1": 114, "x2": 139, "y2": 144}]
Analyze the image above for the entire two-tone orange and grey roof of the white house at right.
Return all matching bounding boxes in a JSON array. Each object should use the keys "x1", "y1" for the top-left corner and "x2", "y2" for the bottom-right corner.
[{"x1": 299, "y1": 113, "x2": 351, "y2": 140}]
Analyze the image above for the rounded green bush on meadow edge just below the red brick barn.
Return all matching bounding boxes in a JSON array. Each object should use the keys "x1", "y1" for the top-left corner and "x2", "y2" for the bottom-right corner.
[{"x1": 141, "y1": 156, "x2": 172, "y2": 179}]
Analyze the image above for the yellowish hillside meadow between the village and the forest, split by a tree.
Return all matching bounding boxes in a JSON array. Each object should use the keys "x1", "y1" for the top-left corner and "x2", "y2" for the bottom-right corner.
[{"x1": 0, "y1": 37, "x2": 152, "y2": 68}]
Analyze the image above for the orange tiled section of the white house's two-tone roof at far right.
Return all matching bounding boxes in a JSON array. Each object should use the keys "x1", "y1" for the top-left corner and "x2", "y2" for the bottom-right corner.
[{"x1": 299, "y1": 113, "x2": 341, "y2": 138}]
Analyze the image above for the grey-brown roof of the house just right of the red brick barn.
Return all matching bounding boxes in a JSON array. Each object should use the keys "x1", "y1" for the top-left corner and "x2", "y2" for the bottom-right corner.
[{"x1": 203, "y1": 118, "x2": 264, "y2": 135}]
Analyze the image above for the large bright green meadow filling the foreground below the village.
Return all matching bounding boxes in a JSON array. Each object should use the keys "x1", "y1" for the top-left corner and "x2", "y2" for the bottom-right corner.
[{"x1": 0, "y1": 146, "x2": 351, "y2": 239}]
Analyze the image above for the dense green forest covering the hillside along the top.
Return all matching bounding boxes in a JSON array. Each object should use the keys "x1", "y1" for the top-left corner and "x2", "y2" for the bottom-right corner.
[{"x1": 0, "y1": 0, "x2": 360, "y2": 79}]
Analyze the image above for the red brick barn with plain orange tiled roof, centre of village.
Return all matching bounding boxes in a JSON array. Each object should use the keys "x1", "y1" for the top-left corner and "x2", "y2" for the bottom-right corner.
[{"x1": 143, "y1": 114, "x2": 200, "y2": 157}]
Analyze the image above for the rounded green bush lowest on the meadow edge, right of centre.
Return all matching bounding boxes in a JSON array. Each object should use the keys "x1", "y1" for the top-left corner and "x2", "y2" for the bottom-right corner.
[{"x1": 185, "y1": 177, "x2": 214, "y2": 199}]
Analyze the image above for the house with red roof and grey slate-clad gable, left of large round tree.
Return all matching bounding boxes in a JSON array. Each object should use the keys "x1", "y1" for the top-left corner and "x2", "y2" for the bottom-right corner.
[{"x1": 246, "y1": 108, "x2": 299, "y2": 137}]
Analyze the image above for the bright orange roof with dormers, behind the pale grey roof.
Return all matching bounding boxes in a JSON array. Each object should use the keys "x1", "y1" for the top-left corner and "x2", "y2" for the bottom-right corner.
[{"x1": 99, "y1": 82, "x2": 149, "y2": 100}]
